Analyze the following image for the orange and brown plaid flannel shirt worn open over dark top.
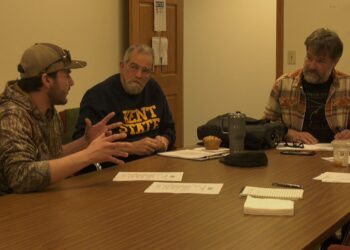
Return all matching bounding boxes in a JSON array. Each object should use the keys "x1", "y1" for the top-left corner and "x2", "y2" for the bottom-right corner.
[{"x1": 264, "y1": 69, "x2": 350, "y2": 133}]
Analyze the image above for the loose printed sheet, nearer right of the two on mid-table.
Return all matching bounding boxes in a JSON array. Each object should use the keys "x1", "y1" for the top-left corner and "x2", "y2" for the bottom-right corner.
[{"x1": 145, "y1": 182, "x2": 224, "y2": 194}]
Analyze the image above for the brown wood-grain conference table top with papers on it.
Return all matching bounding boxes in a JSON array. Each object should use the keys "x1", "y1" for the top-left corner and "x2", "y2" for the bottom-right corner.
[{"x1": 0, "y1": 150, "x2": 350, "y2": 249}]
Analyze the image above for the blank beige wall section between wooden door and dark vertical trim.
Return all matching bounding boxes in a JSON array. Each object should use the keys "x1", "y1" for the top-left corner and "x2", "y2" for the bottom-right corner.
[{"x1": 184, "y1": 0, "x2": 276, "y2": 145}]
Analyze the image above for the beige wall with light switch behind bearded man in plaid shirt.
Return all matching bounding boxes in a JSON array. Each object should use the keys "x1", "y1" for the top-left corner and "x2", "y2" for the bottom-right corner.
[{"x1": 283, "y1": 0, "x2": 350, "y2": 74}]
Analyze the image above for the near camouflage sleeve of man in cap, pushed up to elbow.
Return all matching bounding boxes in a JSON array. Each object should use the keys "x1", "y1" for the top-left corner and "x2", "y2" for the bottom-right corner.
[{"x1": 0, "y1": 111, "x2": 51, "y2": 193}]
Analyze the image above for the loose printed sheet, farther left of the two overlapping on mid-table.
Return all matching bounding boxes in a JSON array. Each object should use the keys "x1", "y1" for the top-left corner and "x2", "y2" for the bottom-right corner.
[{"x1": 113, "y1": 172, "x2": 184, "y2": 181}]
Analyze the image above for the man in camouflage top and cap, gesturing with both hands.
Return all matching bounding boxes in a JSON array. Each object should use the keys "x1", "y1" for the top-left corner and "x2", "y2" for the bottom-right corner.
[{"x1": 0, "y1": 43, "x2": 129, "y2": 194}]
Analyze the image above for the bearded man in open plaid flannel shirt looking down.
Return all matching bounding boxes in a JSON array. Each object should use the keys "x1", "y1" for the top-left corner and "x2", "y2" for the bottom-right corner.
[{"x1": 264, "y1": 28, "x2": 350, "y2": 144}]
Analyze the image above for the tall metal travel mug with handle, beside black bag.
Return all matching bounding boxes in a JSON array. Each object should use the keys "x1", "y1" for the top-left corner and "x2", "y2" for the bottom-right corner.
[{"x1": 221, "y1": 112, "x2": 246, "y2": 154}]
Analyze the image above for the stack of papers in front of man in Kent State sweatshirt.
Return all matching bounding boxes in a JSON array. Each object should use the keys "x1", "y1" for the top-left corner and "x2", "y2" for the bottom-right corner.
[{"x1": 158, "y1": 147, "x2": 230, "y2": 161}]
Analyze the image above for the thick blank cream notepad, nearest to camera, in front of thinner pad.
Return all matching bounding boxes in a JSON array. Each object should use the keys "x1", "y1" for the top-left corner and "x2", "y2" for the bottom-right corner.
[{"x1": 244, "y1": 196, "x2": 294, "y2": 216}]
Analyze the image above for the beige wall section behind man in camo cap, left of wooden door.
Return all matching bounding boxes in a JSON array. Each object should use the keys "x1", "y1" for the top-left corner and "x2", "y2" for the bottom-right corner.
[{"x1": 0, "y1": 0, "x2": 128, "y2": 109}]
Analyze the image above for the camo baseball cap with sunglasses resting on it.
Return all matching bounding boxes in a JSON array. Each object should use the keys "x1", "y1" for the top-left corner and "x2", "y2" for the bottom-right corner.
[{"x1": 17, "y1": 43, "x2": 87, "y2": 79}]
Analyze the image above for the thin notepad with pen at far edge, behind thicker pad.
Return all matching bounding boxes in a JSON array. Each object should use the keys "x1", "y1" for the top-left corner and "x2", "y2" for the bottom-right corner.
[{"x1": 240, "y1": 186, "x2": 304, "y2": 200}]
